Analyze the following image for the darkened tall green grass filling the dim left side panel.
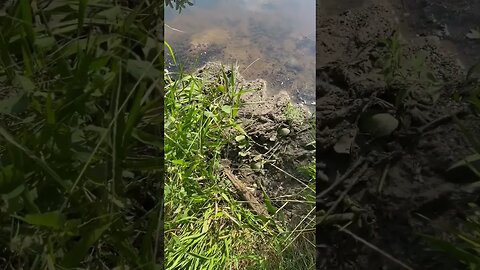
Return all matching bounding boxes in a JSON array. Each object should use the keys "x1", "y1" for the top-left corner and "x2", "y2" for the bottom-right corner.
[{"x1": 0, "y1": 0, "x2": 163, "y2": 269}]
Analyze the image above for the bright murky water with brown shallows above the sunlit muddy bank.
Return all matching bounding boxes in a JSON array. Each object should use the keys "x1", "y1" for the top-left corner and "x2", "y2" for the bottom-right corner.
[{"x1": 165, "y1": 0, "x2": 315, "y2": 104}]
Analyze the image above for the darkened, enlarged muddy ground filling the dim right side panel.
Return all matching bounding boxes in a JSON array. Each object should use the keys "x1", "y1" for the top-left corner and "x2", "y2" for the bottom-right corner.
[{"x1": 316, "y1": 1, "x2": 480, "y2": 269}]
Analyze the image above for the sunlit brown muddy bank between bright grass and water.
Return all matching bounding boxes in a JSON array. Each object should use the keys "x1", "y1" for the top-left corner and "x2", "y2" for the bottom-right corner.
[{"x1": 196, "y1": 62, "x2": 315, "y2": 220}]
